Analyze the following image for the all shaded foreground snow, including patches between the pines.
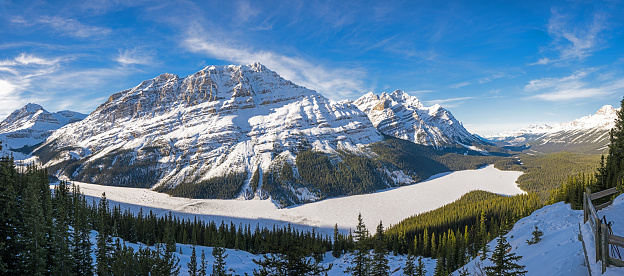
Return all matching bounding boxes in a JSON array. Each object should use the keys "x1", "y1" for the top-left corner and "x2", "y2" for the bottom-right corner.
[{"x1": 93, "y1": 195, "x2": 624, "y2": 276}]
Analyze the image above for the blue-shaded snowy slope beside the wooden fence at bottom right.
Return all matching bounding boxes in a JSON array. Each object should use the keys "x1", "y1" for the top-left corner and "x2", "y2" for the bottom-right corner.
[{"x1": 454, "y1": 195, "x2": 624, "y2": 276}]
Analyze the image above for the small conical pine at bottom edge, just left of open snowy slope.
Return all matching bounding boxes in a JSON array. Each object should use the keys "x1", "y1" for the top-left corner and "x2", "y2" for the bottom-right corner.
[{"x1": 485, "y1": 231, "x2": 527, "y2": 276}]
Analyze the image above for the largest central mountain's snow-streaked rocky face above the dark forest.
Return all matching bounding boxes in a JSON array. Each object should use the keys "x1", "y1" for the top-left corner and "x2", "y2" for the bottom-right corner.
[{"x1": 35, "y1": 63, "x2": 382, "y2": 201}]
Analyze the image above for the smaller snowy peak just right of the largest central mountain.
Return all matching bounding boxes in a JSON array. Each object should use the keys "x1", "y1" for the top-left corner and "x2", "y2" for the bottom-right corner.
[{"x1": 353, "y1": 90, "x2": 484, "y2": 150}]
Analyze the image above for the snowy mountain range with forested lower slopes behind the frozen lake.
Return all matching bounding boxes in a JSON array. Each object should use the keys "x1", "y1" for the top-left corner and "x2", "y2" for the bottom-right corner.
[{"x1": 6, "y1": 63, "x2": 607, "y2": 206}]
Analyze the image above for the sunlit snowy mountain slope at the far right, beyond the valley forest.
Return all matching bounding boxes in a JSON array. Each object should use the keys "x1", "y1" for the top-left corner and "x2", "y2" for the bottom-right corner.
[{"x1": 486, "y1": 105, "x2": 620, "y2": 153}]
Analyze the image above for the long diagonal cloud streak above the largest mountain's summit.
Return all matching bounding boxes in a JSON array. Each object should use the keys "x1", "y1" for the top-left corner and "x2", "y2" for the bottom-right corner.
[{"x1": 182, "y1": 27, "x2": 370, "y2": 100}]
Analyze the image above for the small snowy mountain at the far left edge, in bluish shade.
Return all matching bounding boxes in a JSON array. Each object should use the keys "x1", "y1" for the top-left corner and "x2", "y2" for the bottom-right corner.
[{"x1": 0, "y1": 103, "x2": 87, "y2": 154}]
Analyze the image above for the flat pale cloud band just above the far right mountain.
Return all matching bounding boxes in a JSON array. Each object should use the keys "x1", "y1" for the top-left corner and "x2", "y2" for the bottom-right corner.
[{"x1": 524, "y1": 69, "x2": 624, "y2": 102}]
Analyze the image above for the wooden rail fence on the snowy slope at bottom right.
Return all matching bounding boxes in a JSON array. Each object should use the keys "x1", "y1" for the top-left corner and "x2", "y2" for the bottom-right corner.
[{"x1": 583, "y1": 188, "x2": 624, "y2": 273}]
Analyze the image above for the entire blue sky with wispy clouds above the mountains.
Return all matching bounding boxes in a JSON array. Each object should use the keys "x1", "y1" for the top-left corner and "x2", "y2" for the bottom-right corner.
[{"x1": 0, "y1": 0, "x2": 624, "y2": 135}]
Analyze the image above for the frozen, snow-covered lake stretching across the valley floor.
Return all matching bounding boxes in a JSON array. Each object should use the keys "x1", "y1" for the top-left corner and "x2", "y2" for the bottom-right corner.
[{"x1": 70, "y1": 165, "x2": 524, "y2": 234}]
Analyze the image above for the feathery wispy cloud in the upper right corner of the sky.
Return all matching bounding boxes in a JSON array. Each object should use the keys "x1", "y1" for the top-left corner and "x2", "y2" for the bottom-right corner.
[{"x1": 531, "y1": 9, "x2": 609, "y2": 65}]
